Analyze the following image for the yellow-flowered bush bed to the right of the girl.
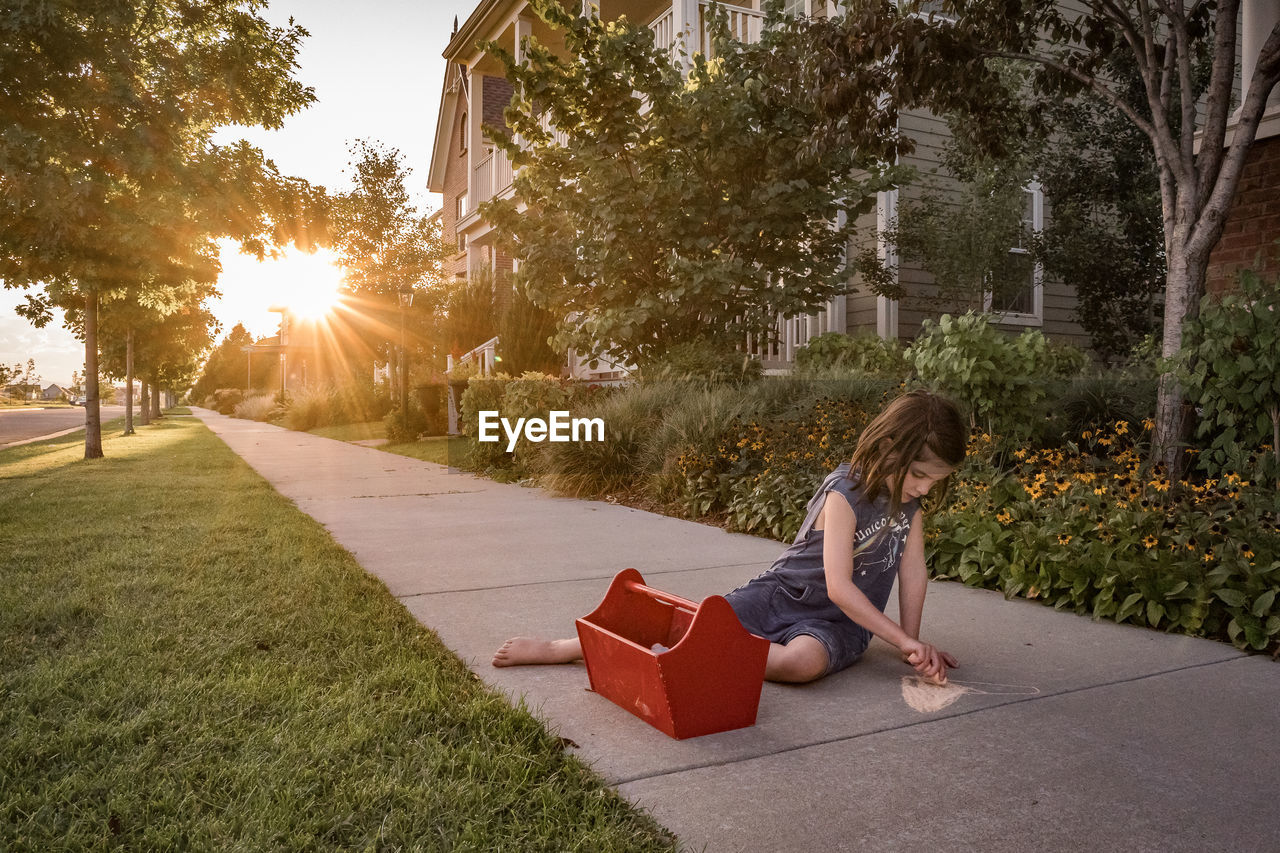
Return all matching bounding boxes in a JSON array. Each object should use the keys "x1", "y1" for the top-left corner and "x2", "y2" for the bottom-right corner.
[{"x1": 925, "y1": 420, "x2": 1280, "y2": 649}]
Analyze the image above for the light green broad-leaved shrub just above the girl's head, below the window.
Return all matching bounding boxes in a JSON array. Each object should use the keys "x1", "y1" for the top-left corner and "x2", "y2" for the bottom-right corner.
[{"x1": 906, "y1": 311, "x2": 1047, "y2": 434}]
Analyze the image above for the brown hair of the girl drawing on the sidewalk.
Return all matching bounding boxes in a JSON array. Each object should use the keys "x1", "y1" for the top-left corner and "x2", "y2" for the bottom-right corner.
[{"x1": 850, "y1": 391, "x2": 969, "y2": 515}]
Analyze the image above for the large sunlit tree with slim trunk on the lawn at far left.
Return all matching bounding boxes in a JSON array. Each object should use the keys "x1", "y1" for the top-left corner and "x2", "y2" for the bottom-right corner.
[{"x1": 0, "y1": 0, "x2": 319, "y2": 459}]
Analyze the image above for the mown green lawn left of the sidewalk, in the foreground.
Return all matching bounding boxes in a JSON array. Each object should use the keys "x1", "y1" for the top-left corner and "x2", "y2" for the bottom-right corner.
[{"x1": 0, "y1": 418, "x2": 675, "y2": 850}]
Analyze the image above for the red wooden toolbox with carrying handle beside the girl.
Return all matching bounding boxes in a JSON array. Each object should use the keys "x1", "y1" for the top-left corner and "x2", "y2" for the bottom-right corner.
[{"x1": 577, "y1": 569, "x2": 769, "y2": 740}]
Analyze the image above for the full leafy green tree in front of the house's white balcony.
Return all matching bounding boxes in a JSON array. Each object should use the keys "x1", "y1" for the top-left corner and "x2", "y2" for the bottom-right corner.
[{"x1": 481, "y1": 0, "x2": 931, "y2": 366}]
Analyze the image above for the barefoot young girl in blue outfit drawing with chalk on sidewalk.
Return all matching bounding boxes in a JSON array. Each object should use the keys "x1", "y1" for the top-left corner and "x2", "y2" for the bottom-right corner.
[{"x1": 493, "y1": 391, "x2": 968, "y2": 684}]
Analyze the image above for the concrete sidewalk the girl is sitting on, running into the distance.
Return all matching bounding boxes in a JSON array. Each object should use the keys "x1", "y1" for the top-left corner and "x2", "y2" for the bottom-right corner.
[{"x1": 193, "y1": 410, "x2": 1280, "y2": 852}]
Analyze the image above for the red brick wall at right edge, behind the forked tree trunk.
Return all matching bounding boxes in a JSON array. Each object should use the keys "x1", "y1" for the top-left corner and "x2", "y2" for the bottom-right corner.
[{"x1": 1206, "y1": 131, "x2": 1280, "y2": 293}]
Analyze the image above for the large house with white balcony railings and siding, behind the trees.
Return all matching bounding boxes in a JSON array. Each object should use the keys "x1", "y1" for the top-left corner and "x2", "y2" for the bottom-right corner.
[{"x1": 428, "y1": 0, "x2": 1131, "y2": 378}]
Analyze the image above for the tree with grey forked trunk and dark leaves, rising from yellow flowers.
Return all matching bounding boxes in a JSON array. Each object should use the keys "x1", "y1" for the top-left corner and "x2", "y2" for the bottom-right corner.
[{"x1": 937, "y1": 0, "x2": 1280, "y2": 469}]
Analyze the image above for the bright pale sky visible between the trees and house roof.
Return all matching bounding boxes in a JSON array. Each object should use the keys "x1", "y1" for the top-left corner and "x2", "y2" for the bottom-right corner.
[{"x1": 0, "y1": 0, "x2": 460, "y2": 386}]
